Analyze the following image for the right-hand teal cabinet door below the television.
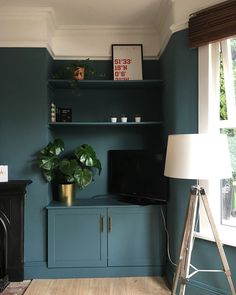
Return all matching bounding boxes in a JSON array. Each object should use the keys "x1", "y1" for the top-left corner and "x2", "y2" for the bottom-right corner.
[{"x1": 108, "y1": 206, "x2": 166, "y2": 266}]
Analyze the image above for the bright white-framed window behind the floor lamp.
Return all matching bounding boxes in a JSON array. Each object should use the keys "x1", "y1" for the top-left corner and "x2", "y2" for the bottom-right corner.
[{"x1": 199, "y1": 38, "x2": 236, "y2": 246}]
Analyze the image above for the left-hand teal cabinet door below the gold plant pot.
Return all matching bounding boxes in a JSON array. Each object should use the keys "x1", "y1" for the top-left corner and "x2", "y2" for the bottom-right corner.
[{"x1": 48, "y1": 208, "x2": 107, "y2": 267}]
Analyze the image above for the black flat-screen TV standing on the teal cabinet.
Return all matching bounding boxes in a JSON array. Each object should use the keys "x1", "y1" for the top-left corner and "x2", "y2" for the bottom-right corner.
[{"x1": 108, "y1": 150, "x2": 168, "y2": 204}]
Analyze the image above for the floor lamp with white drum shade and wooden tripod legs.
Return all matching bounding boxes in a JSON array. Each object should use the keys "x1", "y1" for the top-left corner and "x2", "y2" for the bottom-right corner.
[{"x1": 164, "y1": 134, "x2": 236, "y2": 295}]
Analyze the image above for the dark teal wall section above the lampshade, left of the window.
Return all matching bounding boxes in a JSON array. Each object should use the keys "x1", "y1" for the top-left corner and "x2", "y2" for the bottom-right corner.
[{"x1": 160, "y1": 31, "x2": 198, "y2": 134}]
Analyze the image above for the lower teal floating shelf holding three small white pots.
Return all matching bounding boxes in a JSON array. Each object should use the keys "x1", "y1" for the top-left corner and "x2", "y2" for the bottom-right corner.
[{"x1": 49, "y1": 121, "x2": 163, "y2": 127}]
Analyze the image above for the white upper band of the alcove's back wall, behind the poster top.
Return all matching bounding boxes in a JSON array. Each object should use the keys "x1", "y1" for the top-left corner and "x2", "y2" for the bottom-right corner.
[{"x1": 52, "y1": 26, "x2": 159, "y2": 59}]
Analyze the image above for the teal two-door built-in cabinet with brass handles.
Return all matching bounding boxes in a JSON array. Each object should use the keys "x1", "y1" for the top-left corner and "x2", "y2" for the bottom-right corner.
[{"x1": 48, "y1": 200, "x2": 166, "y2": 268}]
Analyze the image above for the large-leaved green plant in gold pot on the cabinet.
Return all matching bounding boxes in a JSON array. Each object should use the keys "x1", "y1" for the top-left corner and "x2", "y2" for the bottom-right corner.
[{"x1": 38, "y1": 139, "x2": 102, "y2": 205}]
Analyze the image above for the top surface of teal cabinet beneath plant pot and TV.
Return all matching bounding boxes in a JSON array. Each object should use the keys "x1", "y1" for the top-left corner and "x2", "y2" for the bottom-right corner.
[{"x1": 46, "y1": 197, "x2": 161, "y2": 210}]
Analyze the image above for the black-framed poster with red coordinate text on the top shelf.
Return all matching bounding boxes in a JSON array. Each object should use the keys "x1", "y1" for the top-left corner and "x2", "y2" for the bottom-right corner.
[{"x1": 112, "y1": 44, "x2": 143, "y2": 80}]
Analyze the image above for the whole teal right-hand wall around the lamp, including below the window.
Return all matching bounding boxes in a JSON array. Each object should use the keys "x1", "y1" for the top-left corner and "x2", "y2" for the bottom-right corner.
[{"x1": 160, "y1": 30, "x2": 236, "y2": 295}]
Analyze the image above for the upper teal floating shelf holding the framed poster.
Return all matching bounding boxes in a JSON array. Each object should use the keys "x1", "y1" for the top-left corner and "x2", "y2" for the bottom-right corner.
[{"x1": 48, "y1": 79, "x2": 163, "y2": 89}]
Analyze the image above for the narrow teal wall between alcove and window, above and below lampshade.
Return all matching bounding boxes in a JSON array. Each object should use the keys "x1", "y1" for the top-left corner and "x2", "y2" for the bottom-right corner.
[{"x1": 160, "y1": 31, "x2": 198, "y2": 280}]
